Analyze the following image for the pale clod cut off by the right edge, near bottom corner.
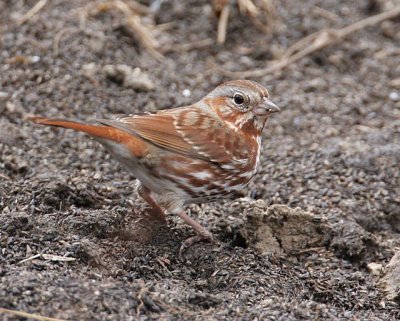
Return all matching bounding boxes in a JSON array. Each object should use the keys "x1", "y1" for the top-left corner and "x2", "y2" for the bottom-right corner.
[{"x1": 378, "y1": 251, "x2": 400, "y2": 302}]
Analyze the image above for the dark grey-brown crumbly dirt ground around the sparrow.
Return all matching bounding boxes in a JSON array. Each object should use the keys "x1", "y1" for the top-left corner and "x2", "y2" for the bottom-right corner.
[{"x1": 0, "y1": 0, "x2": 400, "y2": 320}]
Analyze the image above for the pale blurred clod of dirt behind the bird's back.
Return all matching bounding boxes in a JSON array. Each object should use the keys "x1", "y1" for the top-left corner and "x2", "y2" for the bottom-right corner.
[{"x1": 103, "y1": 65, "x2": 154, "y2": 91}]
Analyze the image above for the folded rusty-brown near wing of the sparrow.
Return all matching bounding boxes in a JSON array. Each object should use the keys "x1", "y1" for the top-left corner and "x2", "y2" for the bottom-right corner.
[{"x1": 98, "y1": 107, "x2": 247, "y2": 164}]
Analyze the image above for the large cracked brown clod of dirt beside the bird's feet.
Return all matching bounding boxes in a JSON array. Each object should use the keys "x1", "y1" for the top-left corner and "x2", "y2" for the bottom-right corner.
[{"x1": 241, "y1": 200, "x2": 331, "y2": 256}]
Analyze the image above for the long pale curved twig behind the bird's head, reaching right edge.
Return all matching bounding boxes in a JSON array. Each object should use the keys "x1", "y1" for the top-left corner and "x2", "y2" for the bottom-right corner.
[{"x1": 218, "y1": 6, "x2": 400, "y2": 78}]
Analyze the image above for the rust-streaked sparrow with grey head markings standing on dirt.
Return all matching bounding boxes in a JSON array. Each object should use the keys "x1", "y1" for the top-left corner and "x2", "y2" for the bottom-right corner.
[{"x1": 30, "y1": 80, "x2": 280, "y2": 255}]
